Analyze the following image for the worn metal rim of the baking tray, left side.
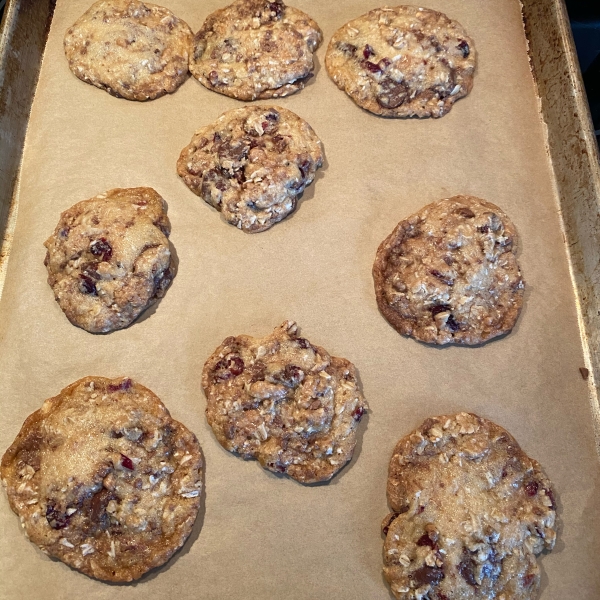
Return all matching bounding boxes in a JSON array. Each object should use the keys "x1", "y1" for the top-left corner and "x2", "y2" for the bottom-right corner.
[{"x1": 0, "y1": 0, "x2": 55, "y2": 296}]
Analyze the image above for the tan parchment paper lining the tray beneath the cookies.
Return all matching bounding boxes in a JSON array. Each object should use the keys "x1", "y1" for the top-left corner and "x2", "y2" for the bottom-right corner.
[{"x1": 0, "y1": 0, "x2": 600, "y2": 600}]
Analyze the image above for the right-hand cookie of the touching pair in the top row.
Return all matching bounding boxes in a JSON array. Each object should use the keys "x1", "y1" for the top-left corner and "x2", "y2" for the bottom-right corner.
[{"x1": 190, "y1": 0, "x2": 323, "y2": 100}]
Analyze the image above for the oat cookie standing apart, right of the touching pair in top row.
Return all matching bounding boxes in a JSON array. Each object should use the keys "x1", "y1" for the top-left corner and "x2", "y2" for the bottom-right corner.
[{"x1": 325, "y1": 6, "x2": 475, "y2": 117}]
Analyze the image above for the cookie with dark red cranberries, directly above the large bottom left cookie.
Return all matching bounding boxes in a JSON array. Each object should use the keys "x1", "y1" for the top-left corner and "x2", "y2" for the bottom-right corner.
[{"x1": 44, "y1": 188, "x2": 175, "y2": 333}]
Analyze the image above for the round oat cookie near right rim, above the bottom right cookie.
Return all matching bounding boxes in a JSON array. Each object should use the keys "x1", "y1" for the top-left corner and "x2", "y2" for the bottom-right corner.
[{"x1": 373, "y1": 196, "x2": 524, "y2": 345}]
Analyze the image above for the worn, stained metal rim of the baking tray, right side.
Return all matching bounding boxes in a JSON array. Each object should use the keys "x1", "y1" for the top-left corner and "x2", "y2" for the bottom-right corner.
[{"x1": 521, "y1": 0, "x2": 600, "y2": 454}]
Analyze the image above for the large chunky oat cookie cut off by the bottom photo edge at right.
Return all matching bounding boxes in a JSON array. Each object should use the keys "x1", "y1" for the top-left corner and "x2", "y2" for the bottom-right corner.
[{"x1": 382, "y1": 413, "x2": 556, "y2": 600}]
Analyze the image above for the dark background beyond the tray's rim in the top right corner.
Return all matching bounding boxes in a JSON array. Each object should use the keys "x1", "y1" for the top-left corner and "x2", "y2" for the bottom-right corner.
[{"x1": 0, "y1": 0, "x2": 600, "y2": 143}]
